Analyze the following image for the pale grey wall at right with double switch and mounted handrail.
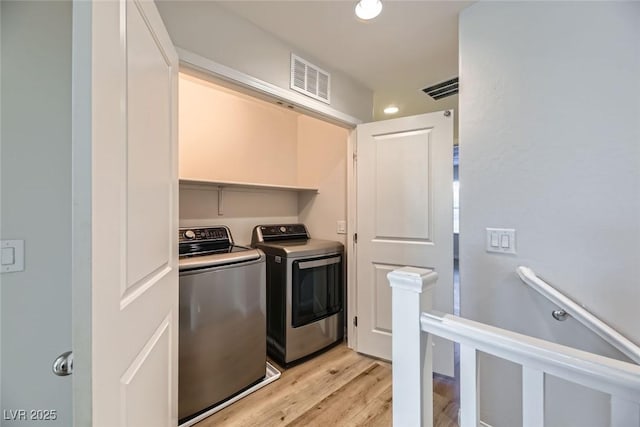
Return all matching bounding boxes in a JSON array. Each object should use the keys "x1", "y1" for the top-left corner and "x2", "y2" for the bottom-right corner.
[{"x1": 460, "y1": 2, "x2": 640, "y2": 427}]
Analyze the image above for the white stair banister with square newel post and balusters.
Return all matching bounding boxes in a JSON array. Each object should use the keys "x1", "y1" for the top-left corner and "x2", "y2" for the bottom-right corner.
[{"x1": 387, "y1": 267, "x2": 640, "y2": 427}]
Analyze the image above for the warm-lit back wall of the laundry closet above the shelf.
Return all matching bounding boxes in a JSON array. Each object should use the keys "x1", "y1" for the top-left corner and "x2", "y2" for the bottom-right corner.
[{"x1": 179, "y1": 73, "x2": 298, "y2": 185}]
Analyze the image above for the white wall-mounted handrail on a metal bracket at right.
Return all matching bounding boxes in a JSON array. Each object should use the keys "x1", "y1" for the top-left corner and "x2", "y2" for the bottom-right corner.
[{"x1": 516, "y1": 267, "x2": 640, "y2": 365}]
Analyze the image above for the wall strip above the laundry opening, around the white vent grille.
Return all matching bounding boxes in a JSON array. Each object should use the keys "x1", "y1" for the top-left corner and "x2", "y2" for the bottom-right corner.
[{"x1": 156, "y1": 1, "x2": 373, "y2": 122}]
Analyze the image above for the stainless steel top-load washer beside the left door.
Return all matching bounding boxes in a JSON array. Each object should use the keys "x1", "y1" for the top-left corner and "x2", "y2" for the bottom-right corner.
[{"x1": 178, "y1": 227, "x2": 267, "y2": 424}]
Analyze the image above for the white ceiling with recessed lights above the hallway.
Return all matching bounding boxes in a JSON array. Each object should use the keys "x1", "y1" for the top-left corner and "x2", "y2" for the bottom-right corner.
[{"x1": 219, "y1": 0, "x2": 473, "y2": 119}]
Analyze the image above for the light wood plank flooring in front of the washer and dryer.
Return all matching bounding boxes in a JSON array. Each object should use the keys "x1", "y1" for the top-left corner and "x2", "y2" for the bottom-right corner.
[{"x1": 195, "y1": 344, "x2": 458, "y2": 427}]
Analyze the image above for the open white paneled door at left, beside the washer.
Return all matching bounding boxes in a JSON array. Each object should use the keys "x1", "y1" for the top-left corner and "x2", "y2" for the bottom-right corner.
[{"x1": 74, "y1": 0, "x2": 178, "y2": 427}]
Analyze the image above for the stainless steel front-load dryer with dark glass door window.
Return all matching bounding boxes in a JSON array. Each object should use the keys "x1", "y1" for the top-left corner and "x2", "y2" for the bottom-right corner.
[{"x1": 251, "y1": 224, "x2": 345, "y2": 365}]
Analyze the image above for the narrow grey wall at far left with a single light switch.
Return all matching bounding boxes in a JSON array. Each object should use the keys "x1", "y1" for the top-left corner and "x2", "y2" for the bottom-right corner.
[{"x1": 0, "y1": 1, "x2": 71, "y2": 427}]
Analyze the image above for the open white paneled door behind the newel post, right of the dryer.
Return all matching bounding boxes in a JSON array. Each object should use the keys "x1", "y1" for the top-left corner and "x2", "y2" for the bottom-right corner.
[{"x1": 355, "y1": 112, "x2": 453, "y2": 376}]
